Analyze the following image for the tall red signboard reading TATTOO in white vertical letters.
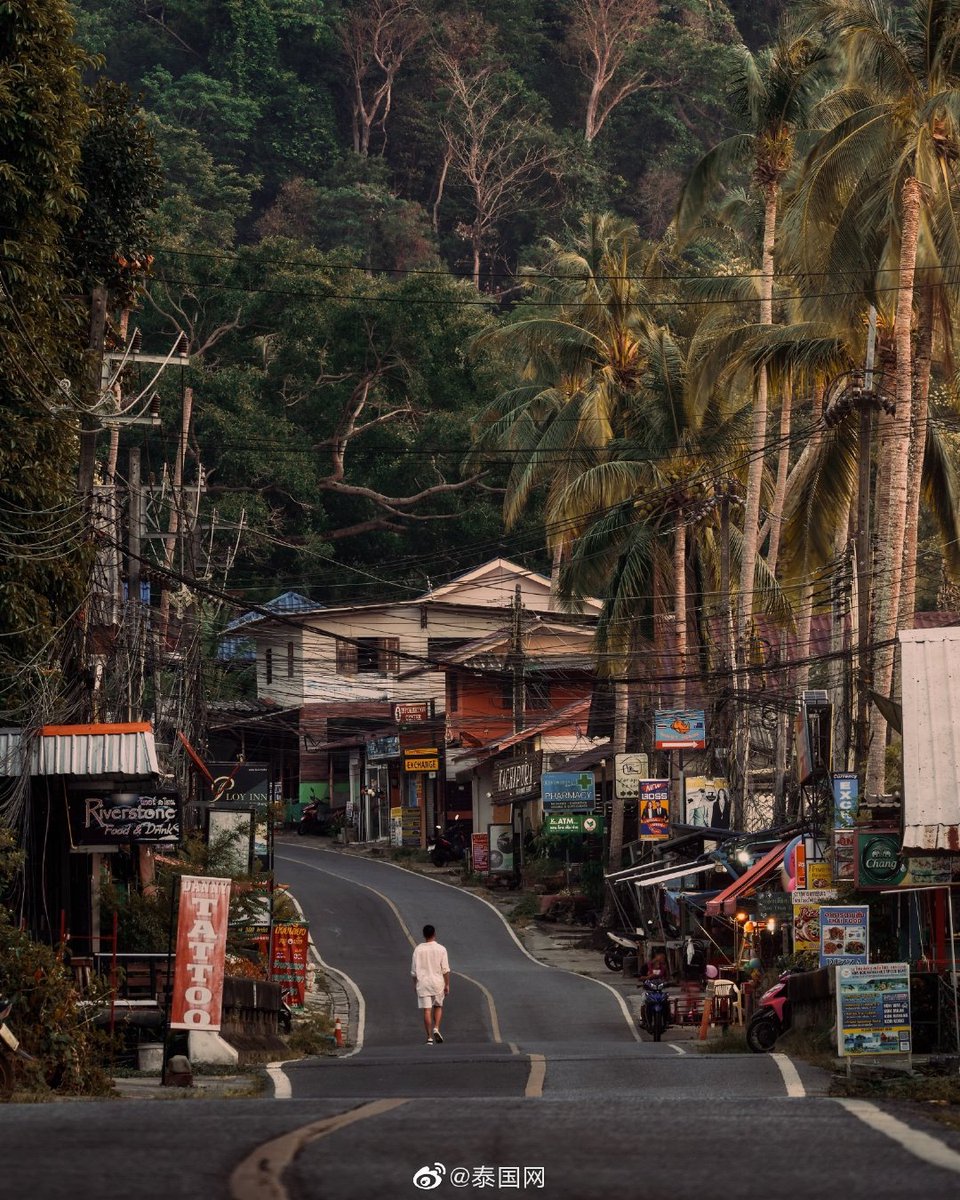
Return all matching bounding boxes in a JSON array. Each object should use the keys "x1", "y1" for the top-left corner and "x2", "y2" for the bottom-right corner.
[{"x1": 170, "y1": 875, "x2": 230, "y2": 1030}]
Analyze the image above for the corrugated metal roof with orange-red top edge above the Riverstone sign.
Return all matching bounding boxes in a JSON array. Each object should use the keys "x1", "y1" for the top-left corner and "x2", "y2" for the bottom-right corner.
[{"x1": 0, "y1": 721, "x2": 160, "y2": 779}]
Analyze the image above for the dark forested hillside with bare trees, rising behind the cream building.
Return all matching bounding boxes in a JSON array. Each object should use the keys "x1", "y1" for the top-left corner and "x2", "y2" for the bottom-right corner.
[{"x1": 69, "y1": 0, "x2": 780, "y2": 598}]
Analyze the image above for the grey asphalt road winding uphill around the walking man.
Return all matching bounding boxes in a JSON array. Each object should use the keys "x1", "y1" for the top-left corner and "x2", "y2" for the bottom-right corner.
[{"x1": 0, "y1": 842, "x2": 960, "y2": 1200}]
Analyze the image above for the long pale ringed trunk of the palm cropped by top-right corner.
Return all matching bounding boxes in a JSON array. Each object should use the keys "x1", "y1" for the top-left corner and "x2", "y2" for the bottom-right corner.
[{"x1": 866, "y1": 176, "x2": 920, "y2": 796}]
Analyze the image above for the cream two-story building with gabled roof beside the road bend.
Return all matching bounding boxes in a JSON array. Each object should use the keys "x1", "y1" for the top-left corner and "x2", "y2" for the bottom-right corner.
[{"x1": 227, "y1": 558, "x2": 600, "y2": 842}]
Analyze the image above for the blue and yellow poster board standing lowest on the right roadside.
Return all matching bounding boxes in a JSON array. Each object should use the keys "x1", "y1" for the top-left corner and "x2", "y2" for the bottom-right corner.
[{"x1": 836, "y1": 962, "x2": 912, "y2": 1055}]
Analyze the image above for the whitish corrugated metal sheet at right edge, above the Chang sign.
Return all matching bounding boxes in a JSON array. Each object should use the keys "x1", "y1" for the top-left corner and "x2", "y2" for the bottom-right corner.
[{"x1": 900, "y1": 626, "x2": 960, "y2": 852}]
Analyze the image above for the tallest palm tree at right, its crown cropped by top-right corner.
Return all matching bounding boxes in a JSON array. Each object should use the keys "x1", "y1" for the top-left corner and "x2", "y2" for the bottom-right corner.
[{"x1": 800, "y1": 0, "x2": 960, "y2": 792}]
